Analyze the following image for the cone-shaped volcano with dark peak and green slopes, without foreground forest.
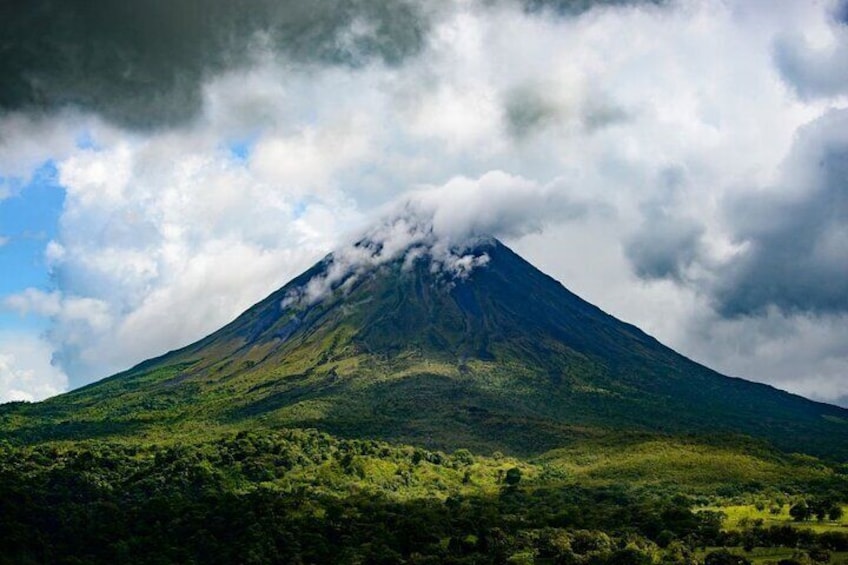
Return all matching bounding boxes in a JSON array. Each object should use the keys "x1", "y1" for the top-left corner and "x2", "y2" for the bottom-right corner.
[{"x1": 0, "y1": 239, "x2": 848, "y2": 461}]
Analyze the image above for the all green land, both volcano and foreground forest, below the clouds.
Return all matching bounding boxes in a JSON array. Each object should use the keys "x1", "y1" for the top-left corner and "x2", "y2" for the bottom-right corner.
[{"x1": 0, "y1": 238, "x2": 848, "y2": 565}]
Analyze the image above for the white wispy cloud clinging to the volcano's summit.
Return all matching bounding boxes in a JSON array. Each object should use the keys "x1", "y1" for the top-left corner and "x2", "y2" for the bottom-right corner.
[{"x1": 282, "y1": 171, "x2": 587, "y2": 307}]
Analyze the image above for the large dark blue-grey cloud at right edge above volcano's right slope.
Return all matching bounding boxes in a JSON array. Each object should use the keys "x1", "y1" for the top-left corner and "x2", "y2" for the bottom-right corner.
[{"x1": 715, "y1": 110, "x2": 848, "y2": 316}]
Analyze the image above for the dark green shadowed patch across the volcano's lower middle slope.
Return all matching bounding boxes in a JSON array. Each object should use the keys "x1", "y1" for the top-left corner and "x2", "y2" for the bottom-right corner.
[{"x1": 222, "y1": 374, "x2": 589, "y2": 457}]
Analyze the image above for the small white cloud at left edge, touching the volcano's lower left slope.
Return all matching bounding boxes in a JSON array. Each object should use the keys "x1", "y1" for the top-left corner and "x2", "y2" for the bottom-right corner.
[{"x1": 0, "y1": 331, "x2": 68, "y2": 402}]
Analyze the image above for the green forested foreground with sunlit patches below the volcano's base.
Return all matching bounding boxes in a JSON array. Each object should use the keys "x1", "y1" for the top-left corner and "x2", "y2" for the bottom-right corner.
[{"x1": 0, "y1": 429, "x2": 848, "y2": 565}]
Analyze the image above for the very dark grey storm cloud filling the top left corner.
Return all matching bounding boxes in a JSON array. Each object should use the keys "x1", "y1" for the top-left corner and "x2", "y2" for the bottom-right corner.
[{"x1": 0, "y1": 0, "x2": 427, "y2": 126}]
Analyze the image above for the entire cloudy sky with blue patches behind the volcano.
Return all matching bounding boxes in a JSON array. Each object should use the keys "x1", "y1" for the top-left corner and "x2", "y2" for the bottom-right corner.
[{"x1": 0, "y1": 0, "x2": 848, "y2": 406}]
